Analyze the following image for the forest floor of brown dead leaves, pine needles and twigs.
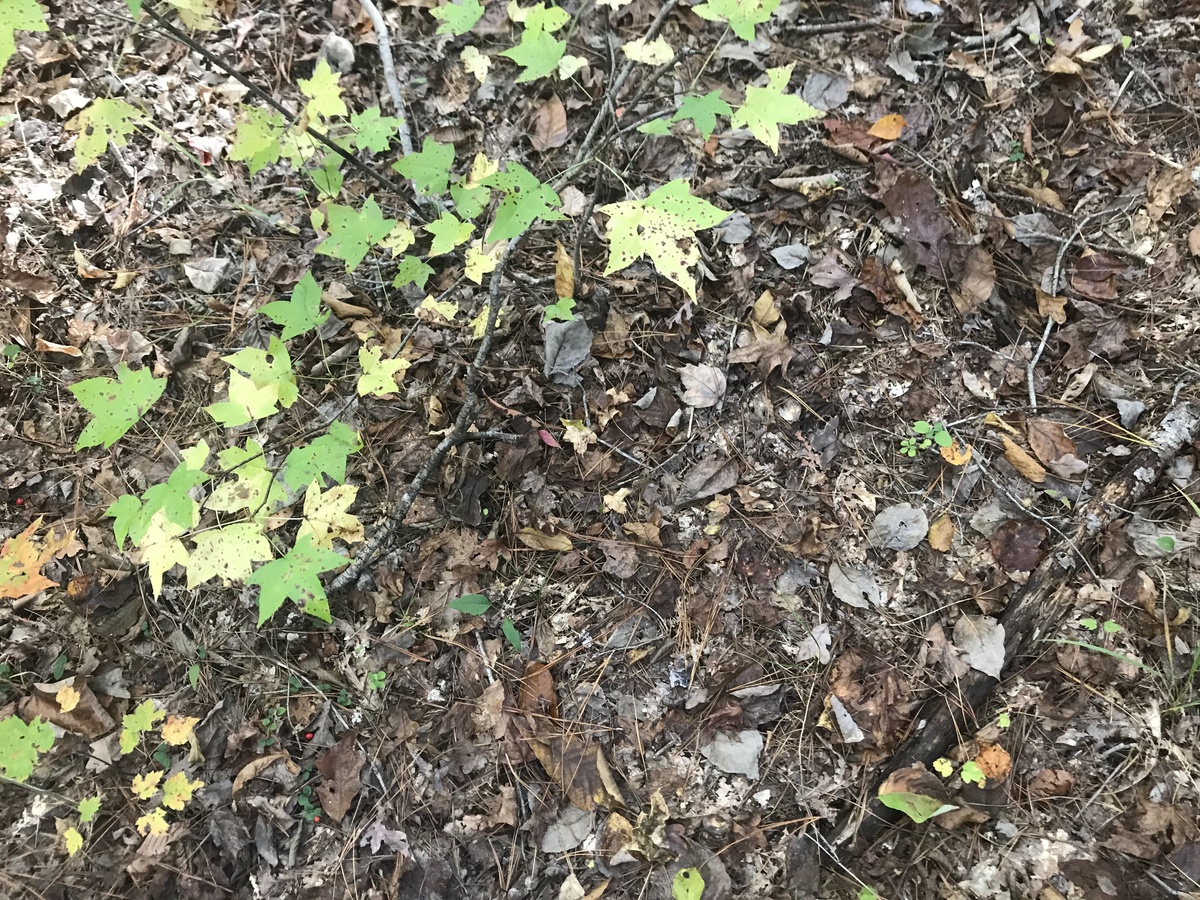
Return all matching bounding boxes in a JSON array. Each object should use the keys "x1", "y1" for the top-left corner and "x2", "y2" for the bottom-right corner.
[{"x1": 0, "y1": 0, "x2": 1200, "y2": 900}]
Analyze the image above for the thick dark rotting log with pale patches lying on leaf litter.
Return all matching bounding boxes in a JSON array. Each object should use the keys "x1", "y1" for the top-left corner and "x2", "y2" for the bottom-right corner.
[{"x1": 827, "y1": 403, "x2": 1200, "y2": 863}]
